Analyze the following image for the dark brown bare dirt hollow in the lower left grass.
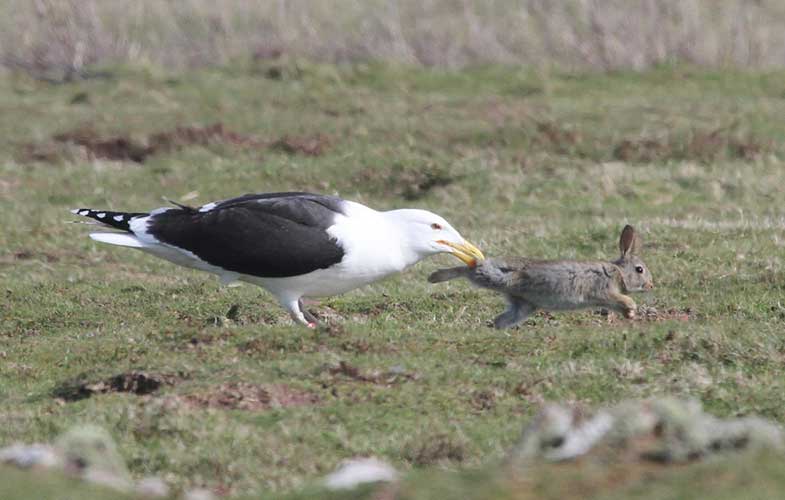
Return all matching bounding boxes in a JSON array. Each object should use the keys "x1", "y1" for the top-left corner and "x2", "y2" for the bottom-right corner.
[{"x1": 53, "y1": 371, "x2": 183, "y2": 401}]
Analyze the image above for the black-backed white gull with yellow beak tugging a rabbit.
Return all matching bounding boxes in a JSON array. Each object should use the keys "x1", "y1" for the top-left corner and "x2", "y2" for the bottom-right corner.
[{"x1": 71, "y1": 192, "x2": 485, "y2": 328}]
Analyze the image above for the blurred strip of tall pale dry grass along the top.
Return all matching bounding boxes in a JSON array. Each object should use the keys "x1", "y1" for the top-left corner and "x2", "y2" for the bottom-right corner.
[{"x1": 0, "y1": 0, "x2": 785, "y2": 78}]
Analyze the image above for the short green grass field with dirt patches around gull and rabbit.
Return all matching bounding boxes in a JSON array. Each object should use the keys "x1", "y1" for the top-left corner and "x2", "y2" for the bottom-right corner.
[{"x1": 0, "y1": 60, "x2": 785, "y2": 498}]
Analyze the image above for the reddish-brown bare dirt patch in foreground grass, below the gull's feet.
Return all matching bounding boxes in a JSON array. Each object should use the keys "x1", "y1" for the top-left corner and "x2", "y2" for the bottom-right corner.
[{"x1": 182, "y1": 382, "x2": 319, "y2": 411}]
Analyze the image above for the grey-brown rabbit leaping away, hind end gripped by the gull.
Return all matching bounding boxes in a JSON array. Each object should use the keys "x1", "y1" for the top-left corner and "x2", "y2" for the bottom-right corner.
[{"x1": 428, "y1": 225, "x2": 654, "y2": 329}]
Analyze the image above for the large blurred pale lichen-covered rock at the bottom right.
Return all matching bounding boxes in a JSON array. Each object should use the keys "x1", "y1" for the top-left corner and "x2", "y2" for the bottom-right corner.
[{"x1": 509, "y1": 397, "x2": 785, "y2": 464}]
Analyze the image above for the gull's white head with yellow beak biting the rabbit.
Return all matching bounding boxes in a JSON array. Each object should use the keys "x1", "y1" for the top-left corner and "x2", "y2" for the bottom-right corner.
[{"x1": 387, "y1": 209, "x2": 485, "y2": 267}]
